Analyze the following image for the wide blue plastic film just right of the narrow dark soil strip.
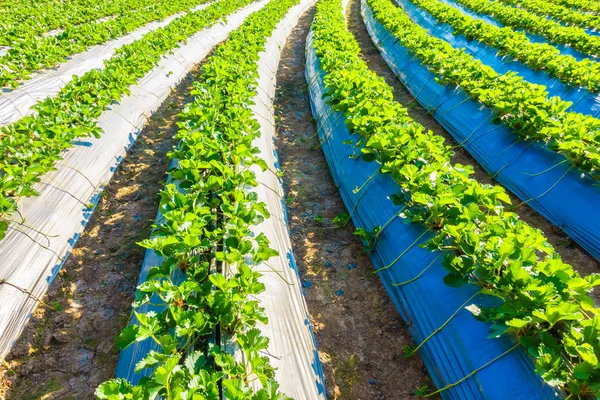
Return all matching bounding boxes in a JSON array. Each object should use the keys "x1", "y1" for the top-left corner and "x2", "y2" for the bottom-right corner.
[{"x1": 362, "y1": 0, "x2": 600, "y2": 258}]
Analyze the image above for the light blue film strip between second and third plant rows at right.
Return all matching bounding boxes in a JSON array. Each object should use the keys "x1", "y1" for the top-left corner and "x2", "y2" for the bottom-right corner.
[{"x1": 394, "y1": 0, "x2": 600, "y2": 117}]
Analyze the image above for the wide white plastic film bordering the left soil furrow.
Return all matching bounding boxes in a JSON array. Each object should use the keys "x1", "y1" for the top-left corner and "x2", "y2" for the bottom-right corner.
[{"x1": 0, "y1": 0, "x2": 266, "y2": 357}]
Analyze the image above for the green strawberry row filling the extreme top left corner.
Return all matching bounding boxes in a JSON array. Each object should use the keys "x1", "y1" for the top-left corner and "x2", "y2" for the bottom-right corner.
[{"x1": 0, "y1": 0, "x2": 152, "y2": 46}]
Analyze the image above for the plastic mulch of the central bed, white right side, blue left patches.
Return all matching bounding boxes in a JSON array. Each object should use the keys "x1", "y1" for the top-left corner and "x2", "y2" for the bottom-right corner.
[{"x1": 117, "y1": 0, "x2": 326, "y2": 400}]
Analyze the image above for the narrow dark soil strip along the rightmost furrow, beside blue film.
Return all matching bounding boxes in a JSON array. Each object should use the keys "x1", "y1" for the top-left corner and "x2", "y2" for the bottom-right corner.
[{"x1": 348, "y1": 0, "x2": 600, "y2": 304}]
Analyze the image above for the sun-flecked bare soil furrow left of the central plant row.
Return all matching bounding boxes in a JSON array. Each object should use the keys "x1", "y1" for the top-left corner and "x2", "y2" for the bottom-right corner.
[{"x1": 0, "y1": 67, "x2": 199, "y2": 400}]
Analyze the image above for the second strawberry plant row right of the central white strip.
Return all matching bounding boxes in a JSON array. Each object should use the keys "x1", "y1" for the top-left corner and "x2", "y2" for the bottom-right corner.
[{"x1": 369, "y1": 1, "x2": 600, "y2": 179}]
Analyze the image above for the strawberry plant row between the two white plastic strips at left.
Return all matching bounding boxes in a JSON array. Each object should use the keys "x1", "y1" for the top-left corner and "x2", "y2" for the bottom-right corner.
[{"x1": 0, "y1": 0, "x2": 252, "y2": 244}]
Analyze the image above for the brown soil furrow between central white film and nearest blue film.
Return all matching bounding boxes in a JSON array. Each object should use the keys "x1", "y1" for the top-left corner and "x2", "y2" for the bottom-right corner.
[{"x1": 275, "y1": 4, "x2": 433, "y2": 400}]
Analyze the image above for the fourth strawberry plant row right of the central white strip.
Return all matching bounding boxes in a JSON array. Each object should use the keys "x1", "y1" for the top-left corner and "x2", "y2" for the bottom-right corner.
[{"x1": 454, "y1": 0, "x2": 600, "y2": 57}]
